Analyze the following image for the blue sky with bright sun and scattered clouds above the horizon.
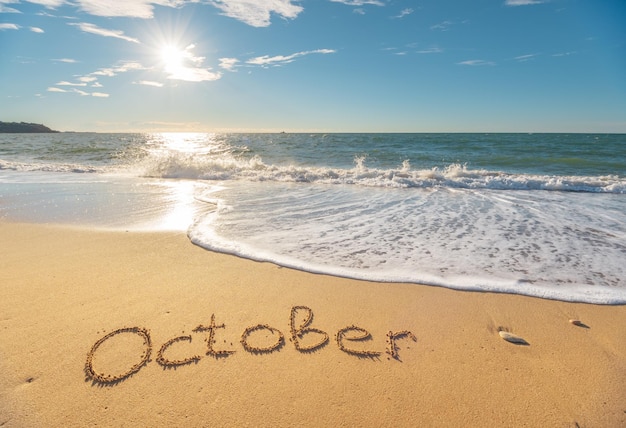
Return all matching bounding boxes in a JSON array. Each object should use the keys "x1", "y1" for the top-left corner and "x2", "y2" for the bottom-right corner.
[{"x1": 0, "y1": 0, "x2": 626, "y2": 132}]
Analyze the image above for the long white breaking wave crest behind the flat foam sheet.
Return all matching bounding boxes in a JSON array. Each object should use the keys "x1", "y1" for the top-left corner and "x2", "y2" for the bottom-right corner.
[{"x1": 137, "y1": 153, "x2": 626, "y2": 194}]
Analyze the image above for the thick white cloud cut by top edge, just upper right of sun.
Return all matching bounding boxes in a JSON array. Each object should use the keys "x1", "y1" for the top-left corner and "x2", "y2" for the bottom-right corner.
[{"x1": 208, "y1": 0, "x2": 303, "y2": 27}]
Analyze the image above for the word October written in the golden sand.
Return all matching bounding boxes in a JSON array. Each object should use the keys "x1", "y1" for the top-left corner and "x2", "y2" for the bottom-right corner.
[{"x1": 85, "y1": 306, "x2": 417, "y2": 384}]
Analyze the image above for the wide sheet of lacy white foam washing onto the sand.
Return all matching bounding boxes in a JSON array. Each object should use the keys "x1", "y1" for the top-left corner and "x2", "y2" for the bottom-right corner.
[{"x1": 189, "y1": 183, "x2": 626, "y2": 304}]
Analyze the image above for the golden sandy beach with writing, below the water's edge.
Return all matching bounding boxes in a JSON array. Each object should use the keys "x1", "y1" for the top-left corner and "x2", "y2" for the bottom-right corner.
[{"x1": 0, "y1": 222, "x2": 626, "y2": 427}]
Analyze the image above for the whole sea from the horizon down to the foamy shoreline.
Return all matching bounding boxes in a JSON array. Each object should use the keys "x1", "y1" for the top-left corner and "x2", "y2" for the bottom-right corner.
[{"x1": 0, "y1": 133, "x2": 626, "y2": 304}]
